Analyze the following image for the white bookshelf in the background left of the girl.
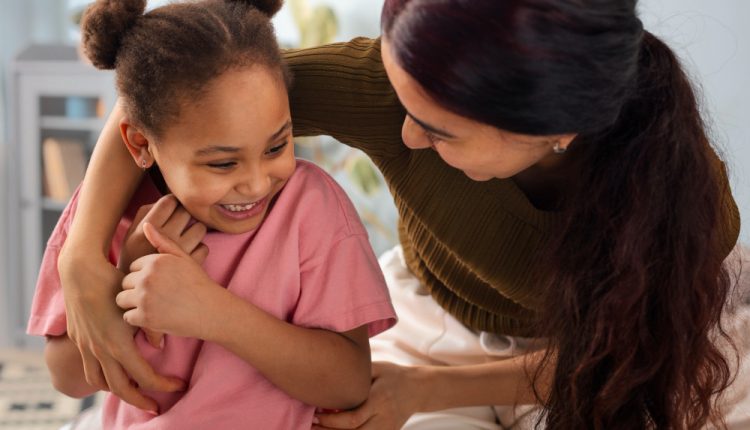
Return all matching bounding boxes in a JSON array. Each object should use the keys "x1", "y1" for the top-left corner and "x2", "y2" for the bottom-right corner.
[{"x1": 0, "y1": 45, "x2": 116, "y2": 348}]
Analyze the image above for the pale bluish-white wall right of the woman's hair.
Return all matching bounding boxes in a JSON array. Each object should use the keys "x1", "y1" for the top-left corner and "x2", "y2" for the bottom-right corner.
[{"x1": 640, "y1": 0, "x2": 750, "y2": 243}]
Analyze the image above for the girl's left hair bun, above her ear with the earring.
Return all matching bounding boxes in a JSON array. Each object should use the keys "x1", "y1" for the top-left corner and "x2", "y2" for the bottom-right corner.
[{"x1": 81, "y1": 0, "x2": 146, "y2": 69}]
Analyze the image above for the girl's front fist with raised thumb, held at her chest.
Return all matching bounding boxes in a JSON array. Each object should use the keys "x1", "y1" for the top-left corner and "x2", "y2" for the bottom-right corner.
[{"x1": 116, "y1": 223, "x2": 225, "y2": 338}]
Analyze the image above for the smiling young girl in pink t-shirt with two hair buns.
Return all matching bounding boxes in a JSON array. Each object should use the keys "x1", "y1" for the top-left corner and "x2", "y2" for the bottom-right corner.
[{"x1": 29, "y1": 0, "x2": 395, "y2": 429}]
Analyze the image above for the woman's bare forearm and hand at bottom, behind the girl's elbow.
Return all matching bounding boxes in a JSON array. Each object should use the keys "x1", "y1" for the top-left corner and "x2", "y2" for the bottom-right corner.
[{"x1": 313, "y1": 350, "x2": 554, "y2": 430}]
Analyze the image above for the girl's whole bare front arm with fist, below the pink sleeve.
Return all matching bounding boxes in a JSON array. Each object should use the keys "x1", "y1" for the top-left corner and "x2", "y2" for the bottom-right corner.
[{"x1": 117, "y1": 224, "x2": 370, "y2": 409}]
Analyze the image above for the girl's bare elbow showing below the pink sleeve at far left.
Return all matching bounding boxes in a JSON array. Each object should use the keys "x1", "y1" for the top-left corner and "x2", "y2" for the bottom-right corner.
[{"x1": 44, "y1": 335, "x2": 98, "y2": 399}]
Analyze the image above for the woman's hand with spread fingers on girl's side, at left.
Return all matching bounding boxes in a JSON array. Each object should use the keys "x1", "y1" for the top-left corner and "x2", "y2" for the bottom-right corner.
[{"x1": 58, "y1": 244, "x2": 185, "y2": 412}]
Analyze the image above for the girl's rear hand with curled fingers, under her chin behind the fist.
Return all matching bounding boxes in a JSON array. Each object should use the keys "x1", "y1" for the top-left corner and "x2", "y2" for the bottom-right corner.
[{"x1": 117, "y1": 194, "x2": 208, "y2": 273}]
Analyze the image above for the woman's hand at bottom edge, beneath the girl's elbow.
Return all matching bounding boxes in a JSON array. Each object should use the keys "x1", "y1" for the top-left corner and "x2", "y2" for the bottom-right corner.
[{"x1": 312, "y1": 362, "x2": 424, "y2": 430}]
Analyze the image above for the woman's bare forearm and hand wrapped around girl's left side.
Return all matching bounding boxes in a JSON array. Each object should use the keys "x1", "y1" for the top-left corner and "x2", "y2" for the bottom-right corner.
[{"x1": 57, "y1": 102, "x2": 183, "y2": 411}]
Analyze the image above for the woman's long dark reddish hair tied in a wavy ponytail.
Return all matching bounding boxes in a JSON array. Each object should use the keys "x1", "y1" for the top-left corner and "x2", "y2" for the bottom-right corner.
[{"x1": 383, "y1": 0, "x2": 739, "y2": 430}]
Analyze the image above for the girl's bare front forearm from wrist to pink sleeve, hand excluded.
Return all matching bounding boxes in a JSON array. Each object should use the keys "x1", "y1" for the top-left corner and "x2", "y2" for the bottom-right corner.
[{"x1": 209, "y1": 288, "x2": 371, "y2": 409}]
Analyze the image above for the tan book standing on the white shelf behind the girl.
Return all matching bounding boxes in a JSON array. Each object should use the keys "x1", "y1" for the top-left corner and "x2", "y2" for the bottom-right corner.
[{"x1": 42, "y1": 137, "x2": 86, "y2": 202}]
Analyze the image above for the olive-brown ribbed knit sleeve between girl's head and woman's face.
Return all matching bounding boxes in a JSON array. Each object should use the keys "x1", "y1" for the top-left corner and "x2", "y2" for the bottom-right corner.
[{"x1": 284, "y1": 38, "x2": 405, "y2": 158}]
